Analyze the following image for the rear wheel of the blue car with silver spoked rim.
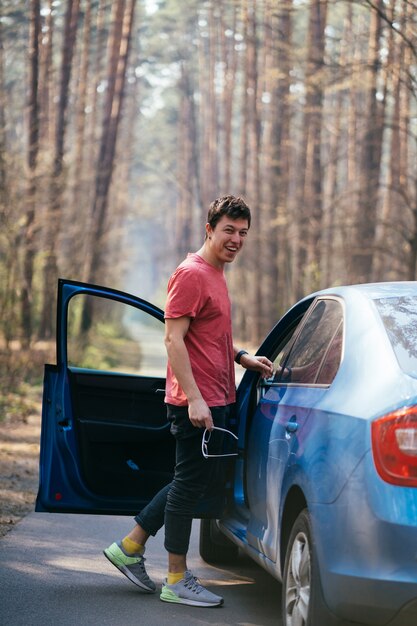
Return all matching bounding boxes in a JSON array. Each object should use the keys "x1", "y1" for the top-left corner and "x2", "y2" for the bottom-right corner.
[{"x1": 282, "y1": 509, "x2": 341, "y2": 626}]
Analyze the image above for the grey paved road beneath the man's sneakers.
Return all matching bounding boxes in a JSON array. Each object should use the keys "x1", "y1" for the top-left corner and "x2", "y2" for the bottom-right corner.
[{"x1": 0, "y1": 513, "x2": 282, "y2": 626}]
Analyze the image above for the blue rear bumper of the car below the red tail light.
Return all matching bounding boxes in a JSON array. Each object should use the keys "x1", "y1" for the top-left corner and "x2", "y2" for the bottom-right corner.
[{"x1": 311, "y1": 442, "x2": 417, "y2": 624}]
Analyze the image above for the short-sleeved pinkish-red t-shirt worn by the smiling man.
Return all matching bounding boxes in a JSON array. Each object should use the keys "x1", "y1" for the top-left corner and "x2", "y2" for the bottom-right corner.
[{"x1": 165, "y1": 253, "x2": 236, "y2": 406}]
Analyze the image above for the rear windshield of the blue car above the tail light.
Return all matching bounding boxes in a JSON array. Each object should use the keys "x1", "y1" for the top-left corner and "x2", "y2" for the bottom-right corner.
[{"x1": 375, "y1": 296, "x2": 417, "y2": 378}]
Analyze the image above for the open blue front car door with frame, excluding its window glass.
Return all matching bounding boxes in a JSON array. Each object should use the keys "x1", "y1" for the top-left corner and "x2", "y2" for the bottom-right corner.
[{"x1": 36, "y1": 279, "x2": 174, "y2": 514}]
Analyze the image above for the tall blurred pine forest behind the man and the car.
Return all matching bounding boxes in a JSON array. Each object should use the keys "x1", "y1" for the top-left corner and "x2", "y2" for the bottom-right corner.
[{"x1": 0, "y1": 0, "x2": 417, "y2": 404}]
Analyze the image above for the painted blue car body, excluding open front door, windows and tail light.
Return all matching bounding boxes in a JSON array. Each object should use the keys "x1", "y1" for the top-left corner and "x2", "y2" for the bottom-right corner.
[{"x1": 220, "y1": 283, "x2": 417, "y2": 624}]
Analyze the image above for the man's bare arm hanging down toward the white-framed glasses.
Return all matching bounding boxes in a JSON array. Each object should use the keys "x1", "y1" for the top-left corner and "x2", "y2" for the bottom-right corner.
[{"x1": 165, "y1": 317, "x2": 213, "y2": 430}]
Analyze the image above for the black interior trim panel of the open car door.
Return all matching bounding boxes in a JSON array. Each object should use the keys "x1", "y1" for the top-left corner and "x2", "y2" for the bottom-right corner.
[{"x1": 69, "y1": 372, "x2": 174, "y2": 498}]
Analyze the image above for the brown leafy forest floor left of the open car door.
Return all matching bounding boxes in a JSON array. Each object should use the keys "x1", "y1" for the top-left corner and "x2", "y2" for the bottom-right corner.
[{"x1": 0, "y1": 390, "x2": 41, "y2": 537}]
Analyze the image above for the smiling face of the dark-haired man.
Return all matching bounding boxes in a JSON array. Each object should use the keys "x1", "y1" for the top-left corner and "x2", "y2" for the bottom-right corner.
[{"x1": 206, "y1": 215, "x2": 249, "y2": 265}]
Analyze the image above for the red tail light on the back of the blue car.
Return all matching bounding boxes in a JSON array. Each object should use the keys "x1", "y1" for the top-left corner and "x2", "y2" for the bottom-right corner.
[{"x1": 372, "y1": 406, "x2": 417, "y2": 487}]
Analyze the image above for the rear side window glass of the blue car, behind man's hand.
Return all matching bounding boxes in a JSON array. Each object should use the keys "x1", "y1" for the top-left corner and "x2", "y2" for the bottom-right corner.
[{"x1": 284, "y1": 299, "x2": 343, "y2": 384}]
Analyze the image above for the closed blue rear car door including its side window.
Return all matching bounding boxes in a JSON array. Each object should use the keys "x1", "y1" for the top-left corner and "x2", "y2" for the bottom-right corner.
[{"x1": 242, "y1": 298, "x2": 343, "y2": 562}]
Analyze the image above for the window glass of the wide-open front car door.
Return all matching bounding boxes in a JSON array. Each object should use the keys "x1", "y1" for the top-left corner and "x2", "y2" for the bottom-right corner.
[{"x1": 67, "y1": 294, "x2": 167, "y2": 377}]
